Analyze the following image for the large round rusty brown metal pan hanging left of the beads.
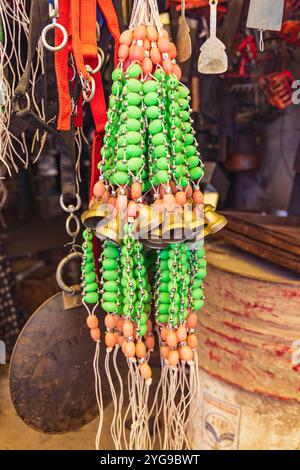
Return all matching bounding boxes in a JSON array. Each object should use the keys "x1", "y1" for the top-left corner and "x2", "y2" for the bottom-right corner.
[{"x1": 9, "y1": 293, "x2": 98, "y2": 434}]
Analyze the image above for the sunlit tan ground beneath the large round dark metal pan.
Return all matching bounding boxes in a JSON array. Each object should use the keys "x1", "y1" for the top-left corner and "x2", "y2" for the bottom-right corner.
[{"x1": 0, "y1": 366, "x2": 113, "y2": 450}]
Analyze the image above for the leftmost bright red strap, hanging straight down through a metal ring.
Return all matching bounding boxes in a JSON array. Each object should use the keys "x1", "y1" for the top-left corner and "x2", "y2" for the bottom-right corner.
[{"x1": 55, "y1": 0, "x2": 71, "y2": 131}]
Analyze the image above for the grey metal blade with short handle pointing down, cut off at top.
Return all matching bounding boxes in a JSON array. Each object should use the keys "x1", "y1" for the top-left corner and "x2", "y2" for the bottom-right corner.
[{"x1": 247, "y1": 0, "x2": 284, "y2": 51}]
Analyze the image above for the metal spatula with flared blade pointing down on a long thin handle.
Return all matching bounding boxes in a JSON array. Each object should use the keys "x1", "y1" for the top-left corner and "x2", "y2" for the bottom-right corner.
[{"x1": 198, "y1": 0, "x2": 228, "y2": 74}]
